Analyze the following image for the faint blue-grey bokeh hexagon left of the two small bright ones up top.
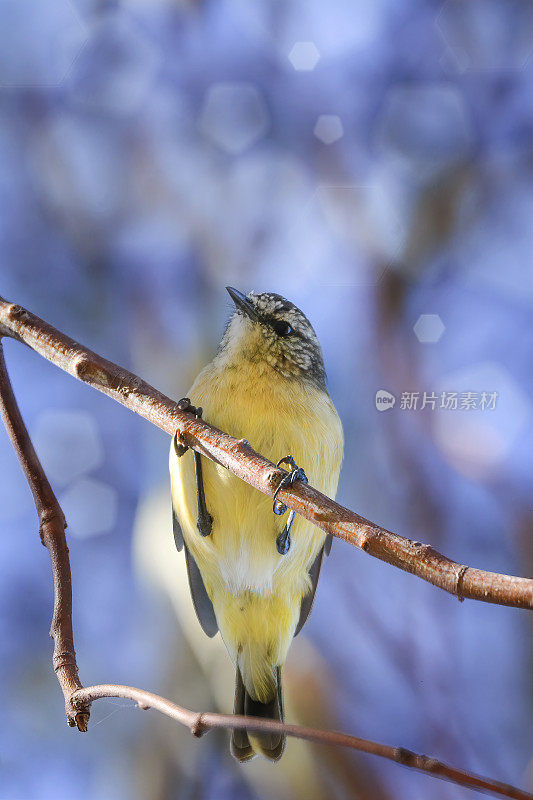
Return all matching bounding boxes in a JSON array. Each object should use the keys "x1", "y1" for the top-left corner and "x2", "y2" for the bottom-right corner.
[{"x1": 199, "y1": 83, "x2": 270, "y2": 155}]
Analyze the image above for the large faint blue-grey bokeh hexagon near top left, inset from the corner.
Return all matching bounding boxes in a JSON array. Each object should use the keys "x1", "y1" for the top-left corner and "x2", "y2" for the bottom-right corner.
[{"x1": 66, "y1": 11, "x2": 160, "y2": 113}]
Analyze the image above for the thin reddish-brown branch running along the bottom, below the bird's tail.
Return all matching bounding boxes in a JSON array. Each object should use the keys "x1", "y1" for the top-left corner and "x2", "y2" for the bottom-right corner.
[{"x1": 72, "y1": 684, "x2": 533, "y2": 800}]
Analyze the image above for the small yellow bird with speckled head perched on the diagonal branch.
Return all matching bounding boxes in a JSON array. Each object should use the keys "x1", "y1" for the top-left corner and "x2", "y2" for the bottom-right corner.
[{"x1": 170, "y1": 287, "x2": 344, "y2": 761}]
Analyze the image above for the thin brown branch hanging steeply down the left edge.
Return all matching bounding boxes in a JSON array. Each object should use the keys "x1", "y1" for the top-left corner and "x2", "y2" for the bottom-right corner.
[{"x1": 0, "y1": 339, "x2": 89, "y2": 731}]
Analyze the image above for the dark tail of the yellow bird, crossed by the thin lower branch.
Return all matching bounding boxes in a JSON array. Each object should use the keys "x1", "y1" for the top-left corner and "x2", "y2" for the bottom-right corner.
[{"x1": 231, "y1": 667, "x2": 285, "y2": 761}]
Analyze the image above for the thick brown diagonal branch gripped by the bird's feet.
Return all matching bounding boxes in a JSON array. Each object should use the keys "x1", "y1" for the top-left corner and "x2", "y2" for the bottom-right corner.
[{"x1": 0, "y1": 298, "x2": 533, "y2": 609}]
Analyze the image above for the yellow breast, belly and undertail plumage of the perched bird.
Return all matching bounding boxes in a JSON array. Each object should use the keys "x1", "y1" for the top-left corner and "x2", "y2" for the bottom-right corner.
[{"x1": 170, "y1": 354, "x2": 343, "y2": 692}]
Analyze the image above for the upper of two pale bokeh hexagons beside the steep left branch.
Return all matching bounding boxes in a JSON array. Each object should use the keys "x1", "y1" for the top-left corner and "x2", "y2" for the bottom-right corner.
[{"x1": 32, "y1": 409, "x2": 104, "y2": 486}]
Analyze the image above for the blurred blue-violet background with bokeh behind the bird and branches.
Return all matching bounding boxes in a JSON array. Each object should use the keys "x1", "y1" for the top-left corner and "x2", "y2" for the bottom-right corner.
[{"x1": 0, "y1": 0, "x2": 533, "y2": 800}]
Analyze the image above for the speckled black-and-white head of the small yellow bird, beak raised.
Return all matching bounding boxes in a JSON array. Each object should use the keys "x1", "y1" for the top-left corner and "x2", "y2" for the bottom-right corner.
[{"x1": 219, "y1": 286, "x2": 325, "y2": 388}]
